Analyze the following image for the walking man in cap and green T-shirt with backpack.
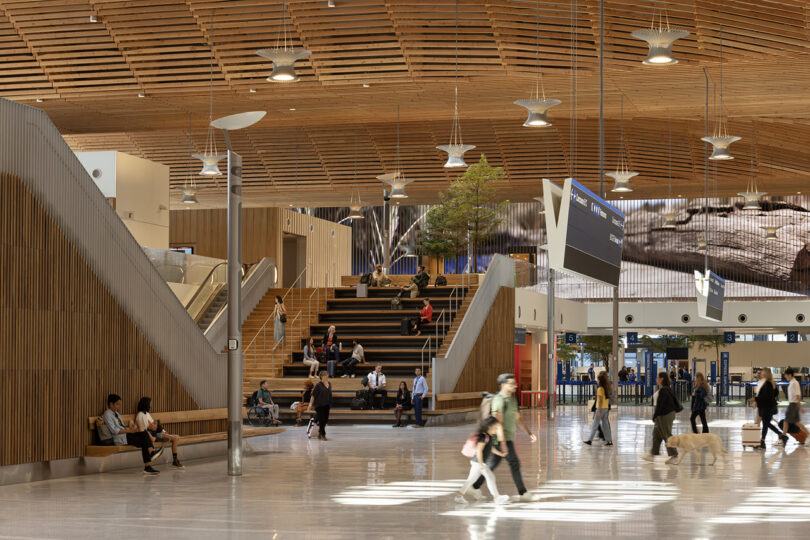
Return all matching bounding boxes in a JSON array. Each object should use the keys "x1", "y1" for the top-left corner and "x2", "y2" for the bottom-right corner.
[{"x1": 472, "y1": 373, "x2": 537, "y2": 502}]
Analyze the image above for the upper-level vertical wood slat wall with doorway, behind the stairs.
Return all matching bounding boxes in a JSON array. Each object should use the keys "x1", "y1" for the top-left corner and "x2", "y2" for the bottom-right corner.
[{"x1": 169, "y1": 208, "x2": 352, "y2": 287}]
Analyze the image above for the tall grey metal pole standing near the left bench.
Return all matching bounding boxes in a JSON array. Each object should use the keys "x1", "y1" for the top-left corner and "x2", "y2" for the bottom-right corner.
[{"x1": 228, "y1": 150, "x2": 242, "y2": 476}]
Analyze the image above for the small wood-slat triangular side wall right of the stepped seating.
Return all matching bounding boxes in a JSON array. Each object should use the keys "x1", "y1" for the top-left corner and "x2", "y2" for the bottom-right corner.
[{"x1": 453, "y1": 287, "x2": 515, "y2": 407}]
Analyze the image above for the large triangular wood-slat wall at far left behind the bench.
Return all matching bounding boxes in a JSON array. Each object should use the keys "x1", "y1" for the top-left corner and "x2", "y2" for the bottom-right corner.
[{"x1": 0, "y1": 174, "x2": 202, "y2": 465}]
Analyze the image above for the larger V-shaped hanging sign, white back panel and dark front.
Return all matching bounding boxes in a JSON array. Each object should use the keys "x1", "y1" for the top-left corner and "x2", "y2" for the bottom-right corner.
[{"x1": 543, "y1": 178, "x2": 625, "y2": 287}]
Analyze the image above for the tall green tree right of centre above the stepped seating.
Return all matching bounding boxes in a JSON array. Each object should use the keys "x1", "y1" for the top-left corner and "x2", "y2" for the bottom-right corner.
[{"x1": 421, "y1": 154, "x2": 508, "y2": 272}]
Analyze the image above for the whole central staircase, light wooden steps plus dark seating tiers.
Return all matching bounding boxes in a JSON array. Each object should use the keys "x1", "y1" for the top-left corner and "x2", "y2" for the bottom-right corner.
[{"x1": 238, "y1": 285, "x2": 476, "y2": 422}]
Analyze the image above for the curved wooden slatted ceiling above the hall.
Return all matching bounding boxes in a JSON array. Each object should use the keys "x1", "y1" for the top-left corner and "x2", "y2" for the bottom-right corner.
[{"x1": 0, "y1": 0, "x2": 810, "y2": 204}]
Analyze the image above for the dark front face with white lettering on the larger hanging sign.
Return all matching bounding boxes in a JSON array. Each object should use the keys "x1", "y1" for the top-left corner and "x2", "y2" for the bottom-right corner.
[{"x1": 563, "y1": 179, "x2": 625, "y2": 286}]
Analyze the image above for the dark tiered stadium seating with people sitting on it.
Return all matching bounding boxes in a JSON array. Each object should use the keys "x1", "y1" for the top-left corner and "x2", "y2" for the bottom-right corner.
[{"x1": 244, "y1": 276, "x2": 476, "y2": 422}]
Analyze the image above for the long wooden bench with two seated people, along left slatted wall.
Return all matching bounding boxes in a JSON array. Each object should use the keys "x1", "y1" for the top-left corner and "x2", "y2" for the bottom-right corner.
[{"x1": 84, "y1": 407, "x2": 286, "y2": 458}]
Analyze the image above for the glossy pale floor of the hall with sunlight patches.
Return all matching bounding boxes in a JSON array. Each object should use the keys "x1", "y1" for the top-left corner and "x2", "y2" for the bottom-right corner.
[{"x1": 0, "y1": 407, "x2": 810, "y2": 540}]
